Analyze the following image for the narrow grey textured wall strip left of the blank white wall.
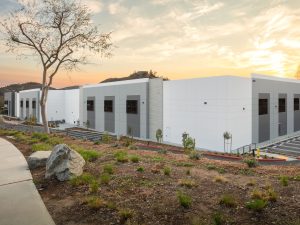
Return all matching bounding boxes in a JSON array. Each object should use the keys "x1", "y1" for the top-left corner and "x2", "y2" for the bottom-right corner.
[{"x1": 149, "y1": 79, "x2": 163, "y2": 140}]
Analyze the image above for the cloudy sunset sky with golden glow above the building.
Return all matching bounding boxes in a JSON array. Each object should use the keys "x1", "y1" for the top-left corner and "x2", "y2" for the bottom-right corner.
[{"x1": 0, "y1": 0, "x2": 300, "y2": 87}]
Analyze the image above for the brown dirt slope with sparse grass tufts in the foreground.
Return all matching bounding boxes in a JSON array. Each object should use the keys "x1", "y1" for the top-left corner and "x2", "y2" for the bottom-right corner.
[{"x1": 1, "y1": 132, "x2": 300, "y2": 225}]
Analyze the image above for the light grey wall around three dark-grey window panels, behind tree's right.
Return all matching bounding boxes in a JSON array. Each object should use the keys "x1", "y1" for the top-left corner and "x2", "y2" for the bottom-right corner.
[{"x1": 80, "y1": 79, "x2": 149, "y2": 138}]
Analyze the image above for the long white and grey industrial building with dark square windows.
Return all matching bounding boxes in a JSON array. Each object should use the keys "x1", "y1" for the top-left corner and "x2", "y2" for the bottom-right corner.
[{"x1": 7, "y1": 74, "x2": 300, "y2": 151}]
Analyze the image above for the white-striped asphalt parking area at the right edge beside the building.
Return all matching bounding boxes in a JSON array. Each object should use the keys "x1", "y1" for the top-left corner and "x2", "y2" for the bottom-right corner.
[{"x1": 262, "y1": 137, "x2": 300, "y2": 158}]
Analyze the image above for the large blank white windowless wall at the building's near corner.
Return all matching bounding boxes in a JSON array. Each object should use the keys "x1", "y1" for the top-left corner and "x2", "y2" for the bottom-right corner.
[{"x1": 163, "y1": 76, "x2": 252, "y2": 151}]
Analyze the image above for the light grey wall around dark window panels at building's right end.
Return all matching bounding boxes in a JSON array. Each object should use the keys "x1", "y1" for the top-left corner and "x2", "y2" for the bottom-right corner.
[{"x1": 252, "y1": 74, "x2": 300, "y2": 143}]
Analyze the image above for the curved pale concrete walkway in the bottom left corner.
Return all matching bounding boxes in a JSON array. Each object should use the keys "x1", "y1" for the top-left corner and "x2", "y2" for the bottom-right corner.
[{"x1": 0, "y1": 138, "x2": 55, "y2": 225}]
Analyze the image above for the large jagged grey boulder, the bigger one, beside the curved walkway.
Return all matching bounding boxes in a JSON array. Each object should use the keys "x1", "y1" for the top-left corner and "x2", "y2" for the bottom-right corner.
[{"x1": 45, "y1": 144, "x2": 85, "y2": 181}]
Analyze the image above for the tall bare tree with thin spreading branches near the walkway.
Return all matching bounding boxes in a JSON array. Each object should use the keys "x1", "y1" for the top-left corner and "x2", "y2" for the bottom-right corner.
[{"x1": 1, "y1": 0, "x2": 112, "y2": 133}]
